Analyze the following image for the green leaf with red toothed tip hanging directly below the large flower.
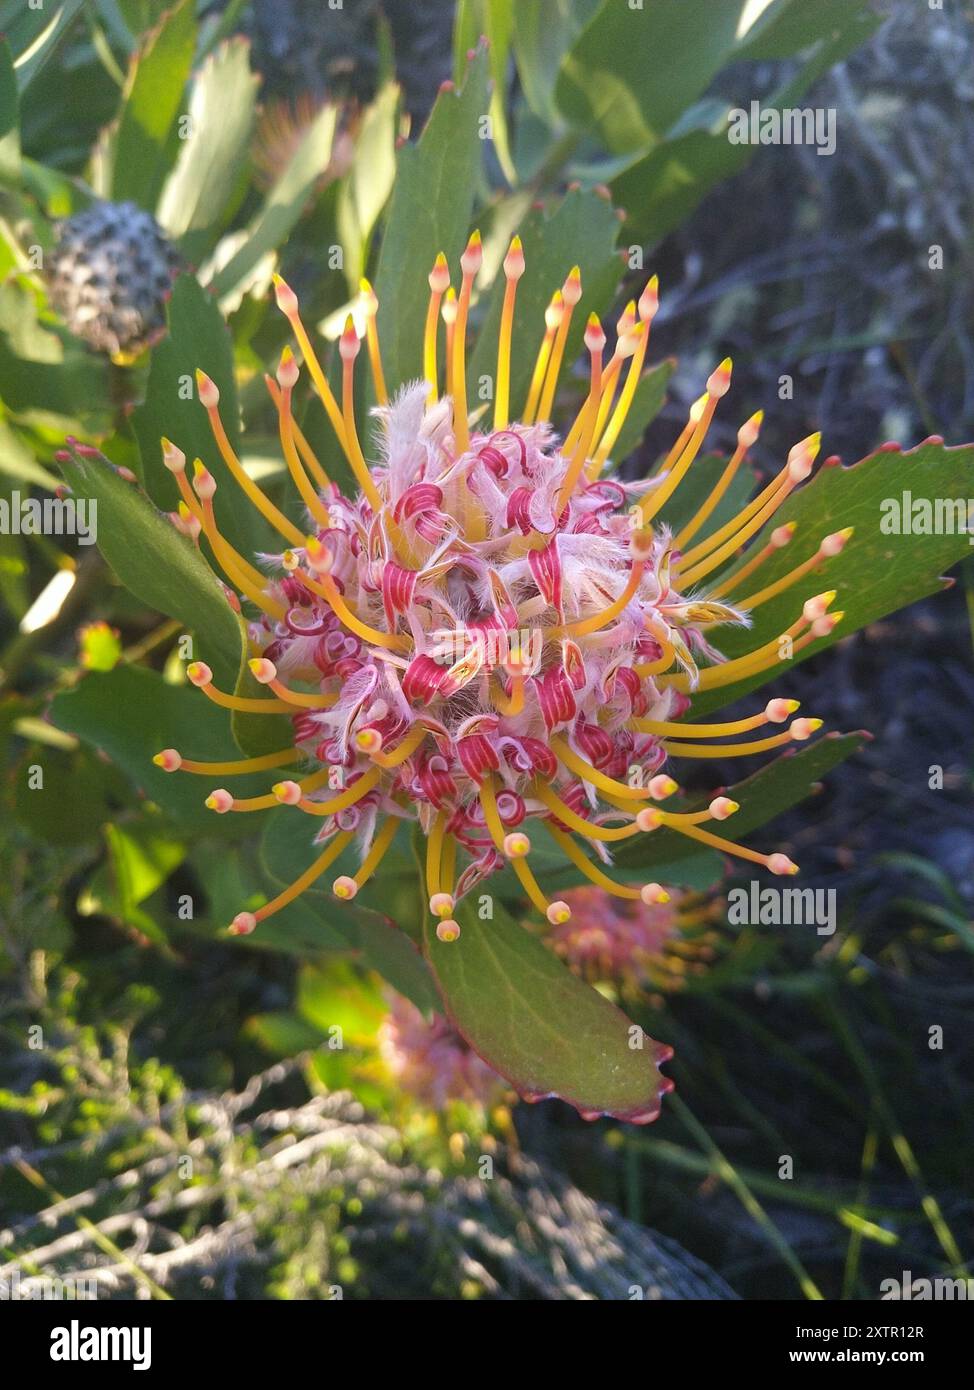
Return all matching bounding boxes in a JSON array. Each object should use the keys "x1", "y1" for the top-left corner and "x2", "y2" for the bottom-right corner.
[{"x1": 424, "y1": 899, "x2": 671, "y2": 1125}]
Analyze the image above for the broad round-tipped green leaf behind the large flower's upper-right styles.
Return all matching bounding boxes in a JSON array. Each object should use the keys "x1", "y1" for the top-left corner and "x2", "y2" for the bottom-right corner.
[{"x1": 464, "y1": 189, "x2": 622, "y2": 418}]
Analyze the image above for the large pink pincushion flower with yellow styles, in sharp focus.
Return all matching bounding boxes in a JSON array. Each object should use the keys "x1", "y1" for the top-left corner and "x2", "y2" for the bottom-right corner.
[{"x1": 147, "y1": 234, "x2": 850, "y2": 941}]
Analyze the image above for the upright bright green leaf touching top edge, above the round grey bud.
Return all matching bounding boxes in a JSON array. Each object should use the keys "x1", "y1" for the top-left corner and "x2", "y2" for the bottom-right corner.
[{"x1": 111, "y1": 0, "x2": 196, "y2": 211}]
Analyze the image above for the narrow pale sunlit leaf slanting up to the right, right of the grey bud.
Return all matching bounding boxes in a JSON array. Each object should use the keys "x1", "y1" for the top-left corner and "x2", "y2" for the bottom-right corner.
[{"x1": 210, "y1": 106, "x2": 338, "y2": 302}]
